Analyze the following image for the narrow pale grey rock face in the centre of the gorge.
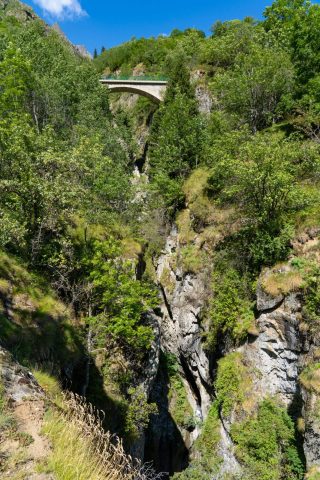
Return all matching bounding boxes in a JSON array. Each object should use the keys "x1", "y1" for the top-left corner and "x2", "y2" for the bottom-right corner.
[{"x1": 157, "y1": 229, "x2": 211, "y2": 419}]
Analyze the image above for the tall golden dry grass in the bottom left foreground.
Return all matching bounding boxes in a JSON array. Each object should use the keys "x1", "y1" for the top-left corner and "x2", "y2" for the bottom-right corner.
[{"x1": 40, "y1": 395, "x2": 161, "y2": 480}]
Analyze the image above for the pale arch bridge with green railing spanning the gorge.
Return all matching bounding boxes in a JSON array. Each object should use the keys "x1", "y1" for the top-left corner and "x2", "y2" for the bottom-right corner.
[{"x1": 100, "y1": 76, "x2": 168, "y2": 103}]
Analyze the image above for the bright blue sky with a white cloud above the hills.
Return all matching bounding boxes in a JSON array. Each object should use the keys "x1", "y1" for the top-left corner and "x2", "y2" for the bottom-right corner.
[{"x1": 24, "y1": 0, "x2": 272, "y2": 52}]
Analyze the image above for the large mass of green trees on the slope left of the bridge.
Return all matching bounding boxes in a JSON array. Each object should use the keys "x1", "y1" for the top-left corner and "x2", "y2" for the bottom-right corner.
[{"x1": 0, "y1": 19, "x2": 132, "y2": 266}]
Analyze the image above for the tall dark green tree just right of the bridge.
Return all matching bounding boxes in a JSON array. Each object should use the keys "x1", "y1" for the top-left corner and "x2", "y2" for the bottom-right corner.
[{"x1": 150, "y1": 54, "x2": 202, "y2": 213}]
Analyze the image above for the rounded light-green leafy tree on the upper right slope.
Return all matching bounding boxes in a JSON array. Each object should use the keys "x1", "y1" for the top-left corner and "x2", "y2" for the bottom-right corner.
[{"x1": 211, "y1": 34, "x2": 294, "y2": 132}]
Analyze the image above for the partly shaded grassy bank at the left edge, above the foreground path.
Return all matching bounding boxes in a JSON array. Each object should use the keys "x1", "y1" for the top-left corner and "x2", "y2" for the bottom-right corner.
[{"x1": 0, "y1": 252, "x2": 84, "y2": 372}]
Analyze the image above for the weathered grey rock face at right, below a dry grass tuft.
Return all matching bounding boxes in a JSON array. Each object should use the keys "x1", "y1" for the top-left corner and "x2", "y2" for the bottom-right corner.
[{"x1": 242, "y1": 287, "x2": 304, "y2": 406}]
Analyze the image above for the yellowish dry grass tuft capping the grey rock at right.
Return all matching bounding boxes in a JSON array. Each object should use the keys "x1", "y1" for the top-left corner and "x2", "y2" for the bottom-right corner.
[{"x1": 262, "y1": 268, "x2": 303, "y2": 297}]
